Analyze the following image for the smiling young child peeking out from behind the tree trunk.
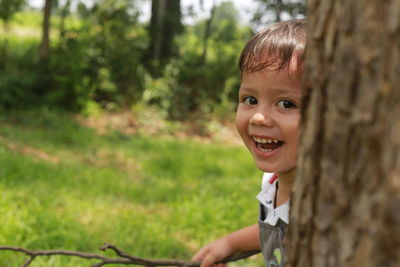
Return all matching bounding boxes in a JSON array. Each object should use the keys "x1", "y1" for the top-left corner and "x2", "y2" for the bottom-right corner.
[{"x1": 192, "y1": 20, "x2": 306, "y2": 267}]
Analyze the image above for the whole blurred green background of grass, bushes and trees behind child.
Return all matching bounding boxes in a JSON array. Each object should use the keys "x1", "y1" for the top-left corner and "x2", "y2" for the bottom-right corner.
[{"x1": 0, "y1": 0, "x2": 305, "y2": 266}]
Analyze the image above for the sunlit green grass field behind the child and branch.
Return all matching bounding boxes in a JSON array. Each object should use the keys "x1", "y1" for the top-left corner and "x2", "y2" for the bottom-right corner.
[{"x1": 0, "y1": 110, "x2": 262, "y2": 267}]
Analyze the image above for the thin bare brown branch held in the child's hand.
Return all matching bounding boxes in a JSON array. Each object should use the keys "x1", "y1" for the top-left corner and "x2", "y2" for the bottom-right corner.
[{"x1": 0, "y1": 243, "x2": 259, "y2": 267}]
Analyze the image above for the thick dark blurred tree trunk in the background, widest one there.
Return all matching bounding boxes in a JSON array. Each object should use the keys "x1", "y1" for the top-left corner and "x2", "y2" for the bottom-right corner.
[{"x1": 145, "y1": 0, "x2": 183, "y2": 76}]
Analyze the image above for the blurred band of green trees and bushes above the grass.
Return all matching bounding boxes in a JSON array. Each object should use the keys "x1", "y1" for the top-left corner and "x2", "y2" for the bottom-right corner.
[{"x1": 0, "y1": 0, "x2": 304, "y2": 120}]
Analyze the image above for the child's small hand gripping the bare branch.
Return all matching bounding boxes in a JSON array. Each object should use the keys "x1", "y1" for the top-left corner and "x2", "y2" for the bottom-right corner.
[{"x1": 192, "y1": 238, "x2": 235, "y2": 267}]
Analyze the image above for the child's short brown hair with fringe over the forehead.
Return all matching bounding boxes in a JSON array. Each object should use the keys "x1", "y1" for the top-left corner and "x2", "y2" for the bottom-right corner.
[{"x1": 239, "y1": 19, "x2": 306, "y2": 78}]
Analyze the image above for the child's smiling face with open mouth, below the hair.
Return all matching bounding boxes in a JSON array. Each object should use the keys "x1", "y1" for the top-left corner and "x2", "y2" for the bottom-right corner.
[{"x1": 235, "y1": 69, "x2": 301, "y2": 177}]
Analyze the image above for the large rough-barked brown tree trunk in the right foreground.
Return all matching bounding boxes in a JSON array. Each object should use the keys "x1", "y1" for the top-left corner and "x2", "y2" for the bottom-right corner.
[{"x1": 287, "y1": 0, "x2": 400, "y2": 267}]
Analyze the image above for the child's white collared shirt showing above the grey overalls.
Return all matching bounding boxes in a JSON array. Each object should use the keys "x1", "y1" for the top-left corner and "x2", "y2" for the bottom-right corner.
[{"x1": 257, "y1": 172, "x2": 289, "y2": 226}]
